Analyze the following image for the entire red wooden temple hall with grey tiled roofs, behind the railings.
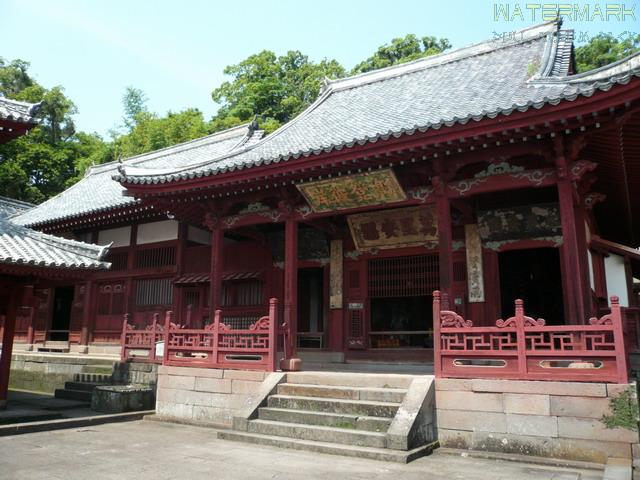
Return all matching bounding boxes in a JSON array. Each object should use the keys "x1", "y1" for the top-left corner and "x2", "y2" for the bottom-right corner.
[{"x1": 5, "y1": 18, "x2": 640, "y2": 361}]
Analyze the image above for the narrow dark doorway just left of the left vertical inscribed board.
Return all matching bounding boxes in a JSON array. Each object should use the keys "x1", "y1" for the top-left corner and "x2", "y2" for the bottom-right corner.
[{"x1": 298, "y1": 268, "x2": 324, "y2": 348}]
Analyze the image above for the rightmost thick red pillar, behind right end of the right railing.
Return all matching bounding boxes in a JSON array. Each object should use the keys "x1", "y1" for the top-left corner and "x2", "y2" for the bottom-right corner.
[{"x1": 558, "y1": 178, "x2": 587, "y2": 324}]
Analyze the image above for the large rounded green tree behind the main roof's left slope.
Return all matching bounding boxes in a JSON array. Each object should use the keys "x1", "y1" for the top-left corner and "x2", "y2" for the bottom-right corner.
[{"x1": 211, "y1": 50, "x2": 345, "y2": 131}]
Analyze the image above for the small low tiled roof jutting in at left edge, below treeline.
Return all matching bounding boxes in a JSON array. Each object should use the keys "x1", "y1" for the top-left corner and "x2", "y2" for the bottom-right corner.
[{"x1": 0, "y1": 198, "x2": 110, "y2": 269}]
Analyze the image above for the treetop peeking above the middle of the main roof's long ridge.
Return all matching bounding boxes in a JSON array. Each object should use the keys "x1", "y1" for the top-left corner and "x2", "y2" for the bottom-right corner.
[{"x1": 351, "y1": 33, "x2": 451, "y2": 75}]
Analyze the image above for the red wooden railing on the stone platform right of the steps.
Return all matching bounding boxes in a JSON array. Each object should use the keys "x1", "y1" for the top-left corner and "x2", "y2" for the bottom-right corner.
[{"x1": 433, "y1": 291, "x2": 628, "y2": 383}]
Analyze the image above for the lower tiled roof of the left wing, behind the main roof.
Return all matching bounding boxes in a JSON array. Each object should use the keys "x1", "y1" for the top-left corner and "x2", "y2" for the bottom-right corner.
[{"x1": 14, "y1": 123, "x2": 263, "y2": 226}]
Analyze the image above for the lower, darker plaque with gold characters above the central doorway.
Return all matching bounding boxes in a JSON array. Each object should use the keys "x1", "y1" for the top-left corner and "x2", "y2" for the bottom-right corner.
[{"x1": 347, "y1": 205, "x2": 438, "y2": 250}]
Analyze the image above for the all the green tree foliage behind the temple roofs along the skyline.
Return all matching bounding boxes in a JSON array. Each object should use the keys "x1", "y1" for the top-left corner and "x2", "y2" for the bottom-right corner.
[{"x1": 0, "y1": 34, "x2": 640, "y2": 203}]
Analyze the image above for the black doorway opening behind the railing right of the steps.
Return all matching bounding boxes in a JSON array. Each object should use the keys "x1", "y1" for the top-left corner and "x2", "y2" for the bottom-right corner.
[{"x1": 498, "y1": 248, "x2": 565, "y2": 325}]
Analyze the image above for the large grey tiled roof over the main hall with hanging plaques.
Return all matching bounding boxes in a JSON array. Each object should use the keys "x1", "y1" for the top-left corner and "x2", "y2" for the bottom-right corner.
[{"x1": 114, "y1": 22, "x2": 640, "y2": 185}]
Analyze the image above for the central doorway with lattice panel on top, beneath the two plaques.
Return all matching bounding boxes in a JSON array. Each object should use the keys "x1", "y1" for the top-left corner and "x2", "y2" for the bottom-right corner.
[{"x1": 368, "y1": 255, "x2": 439, "y2": 348}]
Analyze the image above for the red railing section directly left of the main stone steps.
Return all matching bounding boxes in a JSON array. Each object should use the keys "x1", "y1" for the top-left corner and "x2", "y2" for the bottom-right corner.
[{"x1": 163, "y1": 298, "x2": 278, "y2": 372}]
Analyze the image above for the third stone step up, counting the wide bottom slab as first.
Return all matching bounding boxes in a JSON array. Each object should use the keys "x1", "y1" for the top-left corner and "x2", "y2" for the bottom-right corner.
[{"x1": 258, "y1": 407, "x2": 392, "y2": 432}]
